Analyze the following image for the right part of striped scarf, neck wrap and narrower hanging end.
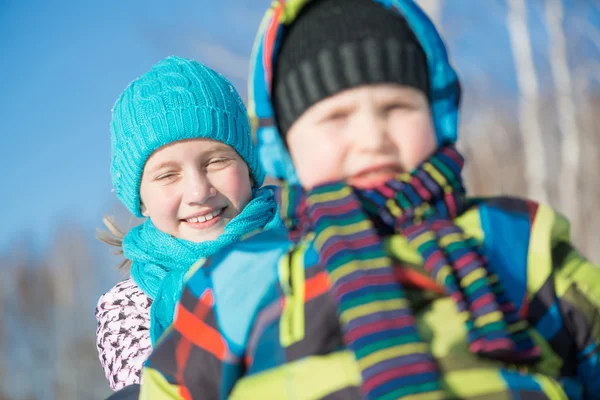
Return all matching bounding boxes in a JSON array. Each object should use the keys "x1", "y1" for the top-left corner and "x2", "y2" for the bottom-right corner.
[{"x1": 358, "y1": 147, "x2": 540, "y2": 364}]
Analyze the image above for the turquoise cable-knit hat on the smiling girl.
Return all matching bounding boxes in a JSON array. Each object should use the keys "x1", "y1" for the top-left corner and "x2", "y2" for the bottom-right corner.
[{"x1": 110, "y1": 57, "x2": 265, "y2": 217}]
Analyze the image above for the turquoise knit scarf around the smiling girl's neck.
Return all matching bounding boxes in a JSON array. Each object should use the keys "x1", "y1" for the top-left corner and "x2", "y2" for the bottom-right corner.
[{"x1": 123, "y1": 187, "x2": 282, "y2": 345}]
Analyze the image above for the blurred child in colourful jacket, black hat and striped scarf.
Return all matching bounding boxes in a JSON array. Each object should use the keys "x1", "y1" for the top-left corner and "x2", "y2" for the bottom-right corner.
[{"x1": 142, "y1": 0, "x2": 600, "y2": 400}]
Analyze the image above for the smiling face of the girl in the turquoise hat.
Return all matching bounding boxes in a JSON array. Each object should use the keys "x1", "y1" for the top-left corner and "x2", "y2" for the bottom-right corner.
[{"x1": 140, "y1": 139, "x2": 252, "y2": 243}]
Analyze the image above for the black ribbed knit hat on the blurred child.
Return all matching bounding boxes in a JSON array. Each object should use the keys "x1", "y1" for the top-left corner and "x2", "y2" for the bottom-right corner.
[{"x1": 272, "y1": 0, "x2": 429, "y2": 134}]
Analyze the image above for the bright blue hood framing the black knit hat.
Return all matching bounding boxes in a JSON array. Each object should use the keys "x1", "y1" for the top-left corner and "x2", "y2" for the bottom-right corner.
[{"x1": 248, "y1": 0, "x2": 460, "y2": 183}]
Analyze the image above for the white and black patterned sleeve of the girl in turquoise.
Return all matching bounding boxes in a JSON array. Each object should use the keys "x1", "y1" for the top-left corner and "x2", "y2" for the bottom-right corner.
[{"x1": 96, "y1": 279, "x2": 152, "y2": 391}]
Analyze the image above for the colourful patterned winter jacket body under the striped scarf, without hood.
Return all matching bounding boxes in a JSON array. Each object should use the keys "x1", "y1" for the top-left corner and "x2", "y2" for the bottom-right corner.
[{"x1": 141, "y1": 198, "x2": 600, "y2": 400}]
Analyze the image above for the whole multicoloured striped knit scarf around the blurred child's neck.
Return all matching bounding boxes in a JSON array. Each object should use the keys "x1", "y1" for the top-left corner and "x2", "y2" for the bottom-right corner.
[{"x1": 279, "y1": 147, "x2": 540, "y2": 400}]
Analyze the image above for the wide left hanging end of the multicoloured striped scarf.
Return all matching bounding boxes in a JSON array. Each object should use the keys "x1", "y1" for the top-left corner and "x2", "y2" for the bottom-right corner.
[{"x1": 307, "y1": 184, "x2": 443, "y2": 399}]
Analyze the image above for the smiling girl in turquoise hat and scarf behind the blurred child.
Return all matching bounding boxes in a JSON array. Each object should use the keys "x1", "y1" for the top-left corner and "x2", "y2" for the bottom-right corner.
[{"x1": 96, "y1": 57, "x2": 280, "y2": 390}]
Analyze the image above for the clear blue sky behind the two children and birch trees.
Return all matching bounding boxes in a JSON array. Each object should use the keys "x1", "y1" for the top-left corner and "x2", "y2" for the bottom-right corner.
[{"x1": 0, "y1": 0, "x2": 600, "y2": 253}]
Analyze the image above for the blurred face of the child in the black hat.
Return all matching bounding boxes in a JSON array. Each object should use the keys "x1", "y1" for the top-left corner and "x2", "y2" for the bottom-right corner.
[{"x1": 286, "y1": 84, "x2": 437, "y2": 189}]
